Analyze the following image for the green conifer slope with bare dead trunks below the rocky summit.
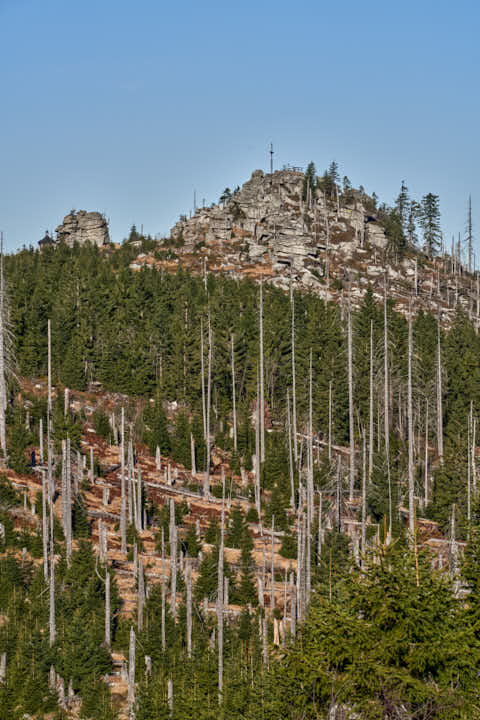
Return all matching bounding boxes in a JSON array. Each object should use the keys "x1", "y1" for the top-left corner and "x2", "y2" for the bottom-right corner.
[{"x1": 0, "y1": 237, "x2": 480, "y2": 720}]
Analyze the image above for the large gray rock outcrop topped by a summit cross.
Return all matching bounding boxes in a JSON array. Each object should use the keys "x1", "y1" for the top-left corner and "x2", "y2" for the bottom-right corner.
[{"x1": 170, "y1": 170, "x2": 386, "y2": 281}]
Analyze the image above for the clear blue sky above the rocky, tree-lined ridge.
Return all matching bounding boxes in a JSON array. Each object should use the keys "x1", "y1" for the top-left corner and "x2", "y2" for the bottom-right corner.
[{"x1": 0, "y1": 0, "x2": 480, "y2": 258}]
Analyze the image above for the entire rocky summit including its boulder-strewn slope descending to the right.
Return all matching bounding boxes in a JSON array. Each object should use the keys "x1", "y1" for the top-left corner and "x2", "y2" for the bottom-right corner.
[{"x1": 156, "y1": 170, "x2": 474, "y2": 324}]
